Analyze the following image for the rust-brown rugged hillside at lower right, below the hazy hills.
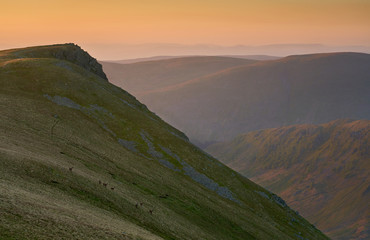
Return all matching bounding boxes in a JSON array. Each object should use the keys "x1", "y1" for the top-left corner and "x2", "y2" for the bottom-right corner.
[{"x1": 207, "y1": 120, "x2": 370, "y2": 239}]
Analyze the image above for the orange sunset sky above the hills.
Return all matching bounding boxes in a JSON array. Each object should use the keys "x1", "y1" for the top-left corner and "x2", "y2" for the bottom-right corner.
[{"x1": 0, "y1": 0, "x2": 370, "y2": 58}]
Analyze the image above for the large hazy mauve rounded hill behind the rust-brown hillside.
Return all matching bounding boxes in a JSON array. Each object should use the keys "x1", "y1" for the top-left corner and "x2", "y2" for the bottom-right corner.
[{"x1": 129, "y1": 53, "x2": 370, "y2": 146}]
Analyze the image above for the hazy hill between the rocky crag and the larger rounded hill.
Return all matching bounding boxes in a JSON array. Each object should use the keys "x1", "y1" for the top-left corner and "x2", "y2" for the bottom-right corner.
[{"x1": 101, "y1": 56, "x2": 256, "y2": 95}]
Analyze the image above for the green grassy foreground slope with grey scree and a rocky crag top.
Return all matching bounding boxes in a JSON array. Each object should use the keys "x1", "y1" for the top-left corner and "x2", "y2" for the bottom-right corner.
[{"x1": 0, "y1": 44, "x2": 327, "y2": 239}]
